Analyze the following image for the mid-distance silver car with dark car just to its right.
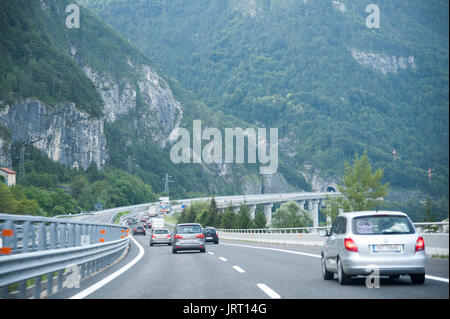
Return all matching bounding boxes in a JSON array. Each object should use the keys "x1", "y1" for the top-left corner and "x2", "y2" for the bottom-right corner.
[{"x1": 172, "y1": 223, "x2": 206, "y2": 254}]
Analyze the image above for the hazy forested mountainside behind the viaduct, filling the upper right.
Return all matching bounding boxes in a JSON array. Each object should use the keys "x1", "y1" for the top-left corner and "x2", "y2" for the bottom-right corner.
[{"x1": 79, "y1": 0, "x2": 449, "y2": 199}]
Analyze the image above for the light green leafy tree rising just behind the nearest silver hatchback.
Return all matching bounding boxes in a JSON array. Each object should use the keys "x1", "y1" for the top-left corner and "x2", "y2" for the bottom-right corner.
[{"x1": 324, "y1": 151, "x2": 389, "y2": 220}]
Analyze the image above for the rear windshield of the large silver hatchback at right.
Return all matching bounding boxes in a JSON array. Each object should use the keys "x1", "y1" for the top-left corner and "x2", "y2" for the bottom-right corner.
[{"x1": 352, "y1": 215, "x2": 414, "y2": 235}]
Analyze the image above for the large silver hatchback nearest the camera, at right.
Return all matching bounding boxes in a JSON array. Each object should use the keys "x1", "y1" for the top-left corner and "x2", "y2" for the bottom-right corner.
[{"x1": 320, "y1": 211, "x2": 426, "y2": 285}]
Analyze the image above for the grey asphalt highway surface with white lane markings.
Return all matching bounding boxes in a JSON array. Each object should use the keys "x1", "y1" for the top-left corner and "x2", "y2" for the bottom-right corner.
[{"x1": 51, "y1": 235, "x2": 449, "y2": 299}]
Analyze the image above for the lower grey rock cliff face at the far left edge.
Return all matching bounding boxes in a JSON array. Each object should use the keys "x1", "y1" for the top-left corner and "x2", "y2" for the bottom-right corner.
[{"x1": 0, "y1": 99, "x2": 108, "y2": 168}]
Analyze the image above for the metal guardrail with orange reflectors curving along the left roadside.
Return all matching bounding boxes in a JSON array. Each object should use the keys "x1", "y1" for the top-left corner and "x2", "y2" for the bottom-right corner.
[{"x1": 0, "y1": 214, "x2": 129, "y2": 298}]
